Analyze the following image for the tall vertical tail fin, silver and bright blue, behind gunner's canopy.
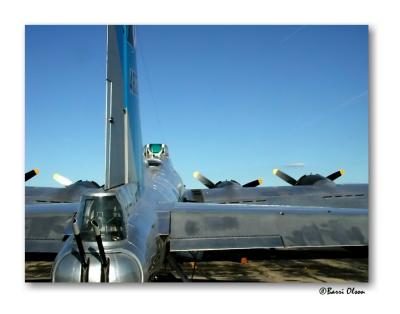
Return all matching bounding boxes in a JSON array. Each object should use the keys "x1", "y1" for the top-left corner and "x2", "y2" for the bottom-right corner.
[{"x1": 105, "y1": 25, "x2": 143, "y2": 190}]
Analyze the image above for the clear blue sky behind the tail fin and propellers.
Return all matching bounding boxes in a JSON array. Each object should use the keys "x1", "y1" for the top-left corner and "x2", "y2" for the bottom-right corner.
[{"x1": 25, "y1": 25, "x2": 368, "y2": 187}]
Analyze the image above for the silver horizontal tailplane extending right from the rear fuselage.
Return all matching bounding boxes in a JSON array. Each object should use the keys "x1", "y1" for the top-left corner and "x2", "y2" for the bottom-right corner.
[{"x1": 159, "y1": 203, "x2": 368, "y2": 252}]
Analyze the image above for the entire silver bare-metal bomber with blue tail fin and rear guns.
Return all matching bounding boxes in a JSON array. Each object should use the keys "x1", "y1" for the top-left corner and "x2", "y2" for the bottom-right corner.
[{"x1": 25, "y1": 26, "x2": 368, "y2": 282}]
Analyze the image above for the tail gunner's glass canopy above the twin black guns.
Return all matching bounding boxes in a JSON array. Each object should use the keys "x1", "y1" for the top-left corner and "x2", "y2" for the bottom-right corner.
[{"x1": 78, "y1": 196, "x2": 126, "y2": 241}]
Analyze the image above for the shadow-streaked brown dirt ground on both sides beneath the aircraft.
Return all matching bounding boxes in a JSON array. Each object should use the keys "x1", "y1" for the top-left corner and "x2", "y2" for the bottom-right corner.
[{"x1": 25, "y1": 251, "x2": 368, "y2": 283}]
